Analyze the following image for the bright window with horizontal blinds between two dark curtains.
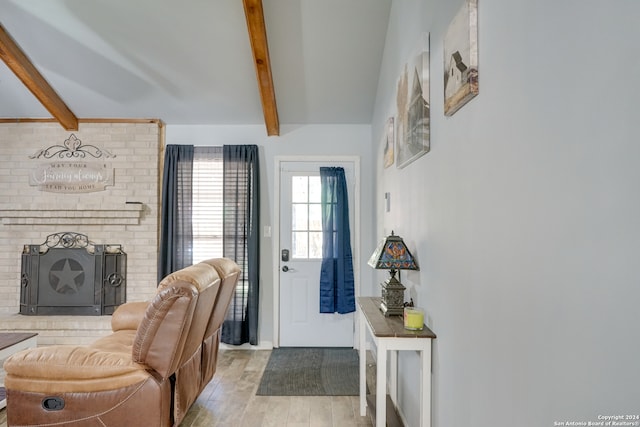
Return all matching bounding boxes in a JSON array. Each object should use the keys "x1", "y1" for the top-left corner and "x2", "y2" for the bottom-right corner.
[{"x1": 192, "y1": 147, "x2": 223, "y2": 263}]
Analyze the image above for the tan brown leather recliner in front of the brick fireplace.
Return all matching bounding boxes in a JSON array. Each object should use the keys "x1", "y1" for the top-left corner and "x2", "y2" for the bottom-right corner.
[{"x1": 4, "y1": 258, "x2": 240, "y2": 427}]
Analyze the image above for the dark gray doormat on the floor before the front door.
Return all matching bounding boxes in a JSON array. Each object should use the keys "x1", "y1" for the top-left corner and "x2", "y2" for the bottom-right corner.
[{"x1": 256, "y1": 347, "x2": 359, "y2": 396}]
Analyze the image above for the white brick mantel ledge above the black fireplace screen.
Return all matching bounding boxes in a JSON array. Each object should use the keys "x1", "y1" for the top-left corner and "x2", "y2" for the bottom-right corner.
[{"x1": 0, "y1": 203, "x2": 145, "y2": 226}]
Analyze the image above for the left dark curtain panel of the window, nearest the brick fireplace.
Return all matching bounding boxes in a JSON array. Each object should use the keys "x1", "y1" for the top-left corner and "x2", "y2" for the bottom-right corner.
[{"x1": 158, "y1": 145, "x2": 193, "y2": 283}]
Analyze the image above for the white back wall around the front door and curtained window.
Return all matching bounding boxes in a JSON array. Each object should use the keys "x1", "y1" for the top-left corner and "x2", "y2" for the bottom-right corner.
[{"x1": 166, "y1": 125, "x2": 375, "y2": 347}]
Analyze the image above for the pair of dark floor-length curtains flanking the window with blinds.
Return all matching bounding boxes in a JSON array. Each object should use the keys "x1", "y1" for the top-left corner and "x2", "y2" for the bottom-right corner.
[{"x1": 158, "y1": 145, "x2": 260, "y2": 345}]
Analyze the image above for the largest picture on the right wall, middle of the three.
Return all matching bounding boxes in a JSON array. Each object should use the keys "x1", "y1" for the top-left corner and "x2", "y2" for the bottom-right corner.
[{"x1": 395, "y1": 33, "x2": 431, "y2": 168}]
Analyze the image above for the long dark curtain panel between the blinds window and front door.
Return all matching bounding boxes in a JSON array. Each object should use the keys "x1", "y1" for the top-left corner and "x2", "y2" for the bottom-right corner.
[{"x1": 221, "y1": 145, "x2": 260, "y2": 345}]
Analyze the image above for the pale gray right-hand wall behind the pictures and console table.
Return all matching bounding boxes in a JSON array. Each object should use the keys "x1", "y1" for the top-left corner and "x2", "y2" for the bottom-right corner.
[{"x1": 372, "y1": 0, "x2": 640, "y2": 427}]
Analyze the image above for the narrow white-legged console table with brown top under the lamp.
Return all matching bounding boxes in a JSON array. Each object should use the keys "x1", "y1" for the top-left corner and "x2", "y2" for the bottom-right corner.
[{"x1": 357, "y1": 297, "x2": 436, "y2": 427}]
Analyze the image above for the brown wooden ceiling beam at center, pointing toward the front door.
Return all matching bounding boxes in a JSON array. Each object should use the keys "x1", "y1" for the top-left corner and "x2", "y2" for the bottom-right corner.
[{"x1": 243, "y1": 0, "x2": 280, "y2": 136}]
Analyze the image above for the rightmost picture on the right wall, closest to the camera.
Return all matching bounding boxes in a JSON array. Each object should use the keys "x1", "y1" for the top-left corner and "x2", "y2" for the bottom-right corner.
[{"x1": 444, "y1": 0, "x2": 478, "y2": 116}]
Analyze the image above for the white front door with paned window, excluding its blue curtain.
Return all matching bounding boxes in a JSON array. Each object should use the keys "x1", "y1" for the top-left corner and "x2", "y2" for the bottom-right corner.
[{"x1": 277, "y1": 162, "x2": 355, "y2": 347}]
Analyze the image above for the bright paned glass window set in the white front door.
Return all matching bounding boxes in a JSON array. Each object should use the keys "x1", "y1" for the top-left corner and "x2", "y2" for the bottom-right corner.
[{"x1": 291, "y1": 175, "x2": 322, "y2": 259}]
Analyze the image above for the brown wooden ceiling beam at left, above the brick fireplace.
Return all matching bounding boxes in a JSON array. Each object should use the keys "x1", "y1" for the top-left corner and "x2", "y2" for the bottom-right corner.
[{"x1": 0, "y1": 24, "x2": 78, "y2": 130}]
